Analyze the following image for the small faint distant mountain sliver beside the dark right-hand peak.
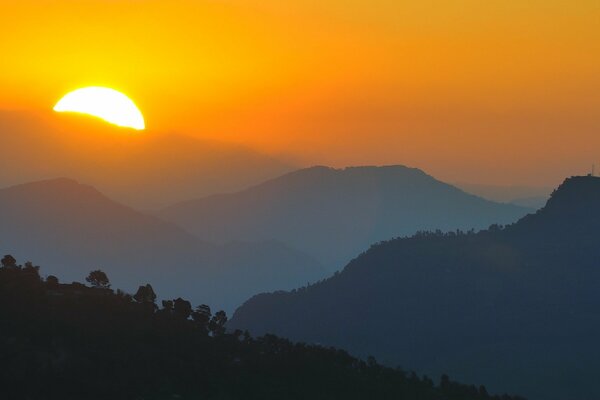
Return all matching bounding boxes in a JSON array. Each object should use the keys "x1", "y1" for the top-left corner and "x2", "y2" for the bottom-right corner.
[{"x1": 456, "y1": 183, "x2": 552, "y2": 210}]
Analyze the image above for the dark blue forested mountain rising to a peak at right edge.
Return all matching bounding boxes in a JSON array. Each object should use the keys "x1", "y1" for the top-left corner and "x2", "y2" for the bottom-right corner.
[{"x1": 231, "y1": 176, "x2": 600, "y2": 400}]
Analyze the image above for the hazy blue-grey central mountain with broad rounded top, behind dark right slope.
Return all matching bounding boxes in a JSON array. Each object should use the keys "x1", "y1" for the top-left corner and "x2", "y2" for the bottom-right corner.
[{"x1": 157, "y1": 166, "x2": 528, "y2": 271}]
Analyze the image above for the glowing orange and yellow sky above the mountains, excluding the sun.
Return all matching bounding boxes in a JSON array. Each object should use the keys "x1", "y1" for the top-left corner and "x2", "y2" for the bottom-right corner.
[{"x1": 0, "y1": 0, "x2": 600, "y2": 186}]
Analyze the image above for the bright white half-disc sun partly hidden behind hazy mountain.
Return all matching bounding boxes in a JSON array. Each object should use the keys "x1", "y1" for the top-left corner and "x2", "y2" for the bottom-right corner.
[{"x1": 54, "y1": 86, "x2": 146, "y2": 130}]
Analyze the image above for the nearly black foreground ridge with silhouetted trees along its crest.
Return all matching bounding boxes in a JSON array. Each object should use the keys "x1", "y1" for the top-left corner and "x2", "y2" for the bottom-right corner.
[{"x1": 0, "y1": 256, "x2": 520, "y2": 400}]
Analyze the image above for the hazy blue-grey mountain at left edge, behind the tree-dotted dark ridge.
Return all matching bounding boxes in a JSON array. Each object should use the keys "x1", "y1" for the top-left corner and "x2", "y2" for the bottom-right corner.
[{"x1": 0, "y1": 179, "x2": 323, "y2": 311}]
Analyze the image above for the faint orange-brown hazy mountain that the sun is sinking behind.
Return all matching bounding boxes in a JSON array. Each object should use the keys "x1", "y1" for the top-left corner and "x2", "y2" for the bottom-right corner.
[{"x1": 0, "y1": 111, "x2": 293, "y2": 209}]
